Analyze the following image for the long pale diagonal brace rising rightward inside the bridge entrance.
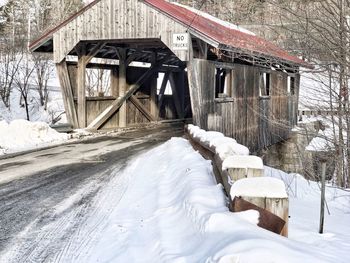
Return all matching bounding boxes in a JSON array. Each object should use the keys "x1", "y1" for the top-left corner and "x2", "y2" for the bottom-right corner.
[{"x1": 88, "y1": 61, "x2": 162, "y2": 130}]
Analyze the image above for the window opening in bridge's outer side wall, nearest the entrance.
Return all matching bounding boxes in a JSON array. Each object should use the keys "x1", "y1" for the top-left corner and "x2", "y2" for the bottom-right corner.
[{"x1": 215, "y1": 68, "x2": 234, "y2": 98}]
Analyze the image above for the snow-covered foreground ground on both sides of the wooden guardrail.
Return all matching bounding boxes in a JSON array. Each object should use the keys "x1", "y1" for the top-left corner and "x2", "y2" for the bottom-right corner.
[{"x1": 74, "y1": 138, "x2": 350, "y2": 263}]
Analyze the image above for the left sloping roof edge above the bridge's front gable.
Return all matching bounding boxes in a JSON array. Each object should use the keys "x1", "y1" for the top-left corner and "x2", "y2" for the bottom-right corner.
[{"x1": 29, "y1": 0, "x2": 101, "y2": 51}]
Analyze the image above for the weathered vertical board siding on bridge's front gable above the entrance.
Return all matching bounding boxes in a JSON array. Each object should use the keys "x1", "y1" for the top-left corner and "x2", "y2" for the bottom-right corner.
[{"x1": 53, "y1": 0, "x2": 188, "y2": 63}]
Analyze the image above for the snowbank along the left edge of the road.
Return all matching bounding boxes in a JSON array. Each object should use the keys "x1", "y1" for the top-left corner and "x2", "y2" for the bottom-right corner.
[{"x1": 0, "y1": 120, "x2": 69, "y2": 154}]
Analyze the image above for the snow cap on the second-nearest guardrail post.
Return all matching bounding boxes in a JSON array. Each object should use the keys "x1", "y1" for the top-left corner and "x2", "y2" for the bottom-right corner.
[{"x1": 222, "y1": 155, "x2": 264, "y2": 170}]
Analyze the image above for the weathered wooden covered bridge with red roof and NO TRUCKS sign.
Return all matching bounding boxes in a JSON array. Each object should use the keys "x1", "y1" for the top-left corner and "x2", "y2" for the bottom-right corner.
[{"x1": 30, "y1": 0, "x2": 308, "y2": 150}]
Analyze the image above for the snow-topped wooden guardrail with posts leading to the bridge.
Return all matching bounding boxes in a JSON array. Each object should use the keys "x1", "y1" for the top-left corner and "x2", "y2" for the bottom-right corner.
[{"x1": 185, "y1": 125, "x2": 289, "y2": 237}]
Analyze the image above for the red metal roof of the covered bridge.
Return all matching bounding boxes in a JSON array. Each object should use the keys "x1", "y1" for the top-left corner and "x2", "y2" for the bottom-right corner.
[{"x1": 30, "y1": 0, "x2": 310, "y2": 67}]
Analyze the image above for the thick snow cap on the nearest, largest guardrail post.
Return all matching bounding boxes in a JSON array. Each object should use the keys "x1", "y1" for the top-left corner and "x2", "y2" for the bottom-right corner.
[{"x1": 230, "y1": 177, "x2": 288, "y2": 198}]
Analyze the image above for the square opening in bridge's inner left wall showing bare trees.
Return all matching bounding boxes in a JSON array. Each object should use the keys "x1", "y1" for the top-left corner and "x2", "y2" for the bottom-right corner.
[{"x1": 86, "y1": 68, "x2": 111, "y2": 97}]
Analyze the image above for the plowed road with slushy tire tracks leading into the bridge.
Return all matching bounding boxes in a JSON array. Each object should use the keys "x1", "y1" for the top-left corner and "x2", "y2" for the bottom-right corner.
[{"x1": 0, "y1": 127, "x2": 182, "y2": 263}]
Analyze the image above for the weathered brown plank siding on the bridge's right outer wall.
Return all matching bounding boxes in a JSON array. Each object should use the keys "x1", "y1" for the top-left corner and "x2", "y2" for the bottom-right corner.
[{"x1": 188, "y1": 59, "x2": 298, "y2": 151}]
